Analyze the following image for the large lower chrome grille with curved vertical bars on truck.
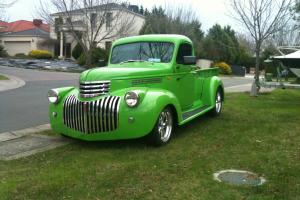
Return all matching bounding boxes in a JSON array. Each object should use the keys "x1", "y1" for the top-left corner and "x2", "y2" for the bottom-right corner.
[{"x1": 63, "y1": 95, "x2": 121, "y2": 134}]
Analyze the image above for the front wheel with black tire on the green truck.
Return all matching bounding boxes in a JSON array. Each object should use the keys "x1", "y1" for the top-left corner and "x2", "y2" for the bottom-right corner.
[{"x1": 148, "y1": 107, "x2": 174, "y2": 146}]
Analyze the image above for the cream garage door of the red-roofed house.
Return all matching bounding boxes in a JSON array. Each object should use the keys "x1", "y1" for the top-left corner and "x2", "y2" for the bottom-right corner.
[{"x1": 4, "y1": 41, "x2": 31, "y2": 56}]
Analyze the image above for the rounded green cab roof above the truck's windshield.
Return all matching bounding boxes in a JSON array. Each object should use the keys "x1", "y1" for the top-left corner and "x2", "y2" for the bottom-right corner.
[{"x1": 113, "y1": 34, "x2": 192, "y2": 46}]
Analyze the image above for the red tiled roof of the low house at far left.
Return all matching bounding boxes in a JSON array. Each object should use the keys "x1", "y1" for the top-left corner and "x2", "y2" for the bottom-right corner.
[{"x1": 0, "y1": 20, "x2": 50, "y2": 33}]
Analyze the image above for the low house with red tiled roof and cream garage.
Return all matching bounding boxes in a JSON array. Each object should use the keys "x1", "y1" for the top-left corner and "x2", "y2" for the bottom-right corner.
[{"x1": 0, "y1": 19, "x2": 53, "y2": 56}]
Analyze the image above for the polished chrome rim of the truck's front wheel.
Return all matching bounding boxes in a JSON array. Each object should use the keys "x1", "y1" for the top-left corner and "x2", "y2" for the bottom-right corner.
[{"x1": 158, "y1": 110, "x2": 173, "y2": 142}]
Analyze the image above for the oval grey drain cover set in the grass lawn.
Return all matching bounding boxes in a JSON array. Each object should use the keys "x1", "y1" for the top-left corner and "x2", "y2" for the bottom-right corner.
[{"x1": 214, "y1": 170, "x2": 266, "y2": 186}]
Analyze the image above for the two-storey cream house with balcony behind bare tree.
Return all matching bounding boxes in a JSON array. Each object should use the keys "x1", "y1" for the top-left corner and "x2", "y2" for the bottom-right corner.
[{"x1": 50, "y1": 3, "x2": 145, "y2": 58}]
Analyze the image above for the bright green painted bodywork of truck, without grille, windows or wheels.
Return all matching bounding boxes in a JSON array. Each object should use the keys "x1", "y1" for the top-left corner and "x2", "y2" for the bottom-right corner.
[{"x1": 49, "y1": 35, "x2": 224, "y2": 141}]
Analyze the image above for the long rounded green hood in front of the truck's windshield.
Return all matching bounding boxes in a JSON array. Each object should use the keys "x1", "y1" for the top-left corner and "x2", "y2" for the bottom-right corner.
[{"x1": 80, "y1": 63, "x2": 170, "y2": 82}]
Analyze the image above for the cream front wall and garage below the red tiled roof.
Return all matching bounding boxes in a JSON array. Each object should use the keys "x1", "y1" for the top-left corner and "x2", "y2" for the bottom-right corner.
[{"x1": 0, "y1": 36, "x2": 53, "y2": 56}]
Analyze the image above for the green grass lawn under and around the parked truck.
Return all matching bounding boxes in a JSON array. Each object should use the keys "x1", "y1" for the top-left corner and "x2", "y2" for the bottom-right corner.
[{"x1": 0, "y1": 90, "x2": 300, "y2": 200}]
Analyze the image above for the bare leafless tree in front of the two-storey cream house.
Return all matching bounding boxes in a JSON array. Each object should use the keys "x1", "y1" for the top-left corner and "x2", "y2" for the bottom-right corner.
[{"x1": 38, "y1": 0, "x2": 135, "y2": 66}]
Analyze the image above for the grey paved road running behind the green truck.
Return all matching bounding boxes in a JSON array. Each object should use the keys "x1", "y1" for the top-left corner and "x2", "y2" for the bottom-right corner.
[{"x1": 0, "y1": 66, "x2": 252, "y2": 133}]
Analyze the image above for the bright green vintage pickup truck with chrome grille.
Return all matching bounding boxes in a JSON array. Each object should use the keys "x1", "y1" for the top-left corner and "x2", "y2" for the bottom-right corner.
[{"x1": 48, "y1": 35, "x2": 224, "y2": 145}]
